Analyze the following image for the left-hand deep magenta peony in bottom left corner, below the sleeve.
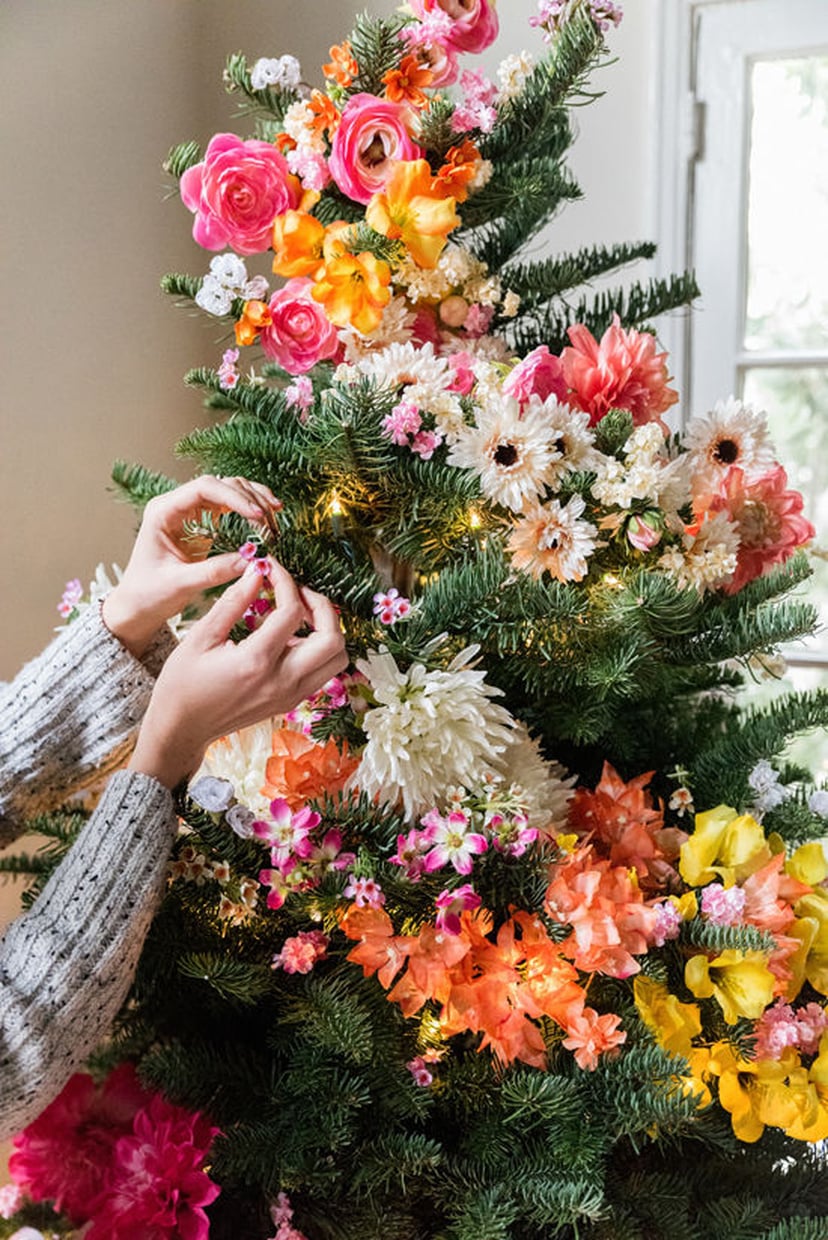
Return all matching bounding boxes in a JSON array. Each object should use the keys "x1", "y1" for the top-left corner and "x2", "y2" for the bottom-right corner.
[{"x1": 9, "y1": 1064, "x2": 150, "y2": 1223}]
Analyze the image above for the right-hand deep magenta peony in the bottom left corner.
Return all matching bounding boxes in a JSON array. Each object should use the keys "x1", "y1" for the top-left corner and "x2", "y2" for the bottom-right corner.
[{"x1": 84, "y1": 1094, "x2": 221, "y2": 1240}]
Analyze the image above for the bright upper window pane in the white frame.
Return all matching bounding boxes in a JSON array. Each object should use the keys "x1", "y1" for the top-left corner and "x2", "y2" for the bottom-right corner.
[{"x1": 745, "y1": 55, "x2": 828, "y2": 348}]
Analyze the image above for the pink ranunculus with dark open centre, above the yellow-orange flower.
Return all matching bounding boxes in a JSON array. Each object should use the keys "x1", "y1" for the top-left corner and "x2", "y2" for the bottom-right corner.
[{"x1": 327, "y1": 93, "x2": 424, "y2": 203}]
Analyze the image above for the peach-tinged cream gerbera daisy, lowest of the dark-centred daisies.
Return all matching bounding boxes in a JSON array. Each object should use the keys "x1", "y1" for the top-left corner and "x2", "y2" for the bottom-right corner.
[{"x1": 507, "y1": 495, "x2": 597, "y2": 582}]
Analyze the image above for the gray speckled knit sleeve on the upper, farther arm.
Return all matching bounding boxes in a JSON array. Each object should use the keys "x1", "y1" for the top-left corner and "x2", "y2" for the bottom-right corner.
[{"x1": 0, "y1": 606, "x2": 175, "y2": 847}]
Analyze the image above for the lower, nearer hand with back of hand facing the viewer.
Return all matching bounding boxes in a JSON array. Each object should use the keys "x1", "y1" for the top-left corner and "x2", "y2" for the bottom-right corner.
[{"x1": 129, "y1": 560, "x2": 348, "y2": 787}]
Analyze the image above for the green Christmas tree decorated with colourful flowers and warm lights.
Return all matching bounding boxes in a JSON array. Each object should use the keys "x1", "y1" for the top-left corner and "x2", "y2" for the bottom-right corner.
[{"x1": 0, "y1": 0, "x2": 828, "y2": 1240}]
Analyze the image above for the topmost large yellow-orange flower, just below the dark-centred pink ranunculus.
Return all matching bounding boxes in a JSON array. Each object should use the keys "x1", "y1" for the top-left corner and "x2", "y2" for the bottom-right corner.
[{"x1": 366, "y1": 159, "x2": 460, "y2": 268}]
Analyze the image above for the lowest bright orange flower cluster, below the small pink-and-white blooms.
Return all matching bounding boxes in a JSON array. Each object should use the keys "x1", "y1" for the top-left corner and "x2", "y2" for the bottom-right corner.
[{"x1": 340, "y1": 906, "x2": 626, "y2": 1069}]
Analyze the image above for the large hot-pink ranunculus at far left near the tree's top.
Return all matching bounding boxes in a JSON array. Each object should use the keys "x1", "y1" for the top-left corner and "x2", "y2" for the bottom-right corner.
[{"x1": 181, "y1": 134, "x2": 300, "y2": 254}]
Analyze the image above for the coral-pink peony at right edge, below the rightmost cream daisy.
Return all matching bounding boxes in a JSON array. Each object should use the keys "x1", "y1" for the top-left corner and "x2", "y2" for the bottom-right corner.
[{"x1": 710, "y1": 465, "x2": 816, "y2": 594}]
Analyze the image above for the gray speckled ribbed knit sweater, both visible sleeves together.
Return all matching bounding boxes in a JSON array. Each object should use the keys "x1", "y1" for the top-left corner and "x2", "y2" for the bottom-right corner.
[{"x1": 0, "y1": 606, "x2": 176, "y2": 1137}]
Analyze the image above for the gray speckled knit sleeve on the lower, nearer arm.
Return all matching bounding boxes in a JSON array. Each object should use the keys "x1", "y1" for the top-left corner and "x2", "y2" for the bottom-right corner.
[{"x1": 0, "y1": 771, "x2": 176, "y2": 1138}]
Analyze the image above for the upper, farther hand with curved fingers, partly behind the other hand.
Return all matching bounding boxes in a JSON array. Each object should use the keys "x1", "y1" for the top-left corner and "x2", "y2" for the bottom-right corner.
[{"x1": 102, "y1": 475, "x2": 280, "y2": 658}]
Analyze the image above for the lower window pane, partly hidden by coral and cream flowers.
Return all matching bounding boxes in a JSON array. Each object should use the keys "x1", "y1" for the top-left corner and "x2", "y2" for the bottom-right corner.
[{"x1": 744, "y1": 366, "x2": 828, "y2": 662}]
